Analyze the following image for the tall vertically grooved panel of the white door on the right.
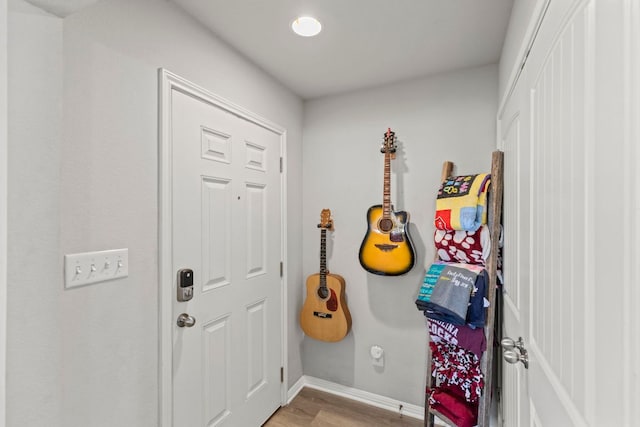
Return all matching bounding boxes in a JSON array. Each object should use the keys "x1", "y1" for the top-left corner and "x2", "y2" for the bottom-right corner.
[{"x1": 530, "y1": 2, "x2": 591, "y2": 414}]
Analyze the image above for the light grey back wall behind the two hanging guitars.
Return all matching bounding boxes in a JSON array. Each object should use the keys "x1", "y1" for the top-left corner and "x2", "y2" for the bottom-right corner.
[{"x1": 300, "y1": 66, "x2": 498, "y2": 405}]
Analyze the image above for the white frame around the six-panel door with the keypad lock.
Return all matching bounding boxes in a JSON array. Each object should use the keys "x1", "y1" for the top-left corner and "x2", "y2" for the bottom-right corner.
[{"x1": 158, "y1": 68, "x2": 288, "y2": 427}]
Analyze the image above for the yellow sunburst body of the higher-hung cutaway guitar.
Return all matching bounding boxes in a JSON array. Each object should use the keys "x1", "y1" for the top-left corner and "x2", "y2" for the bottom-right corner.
[{"x1": 360, "y1": 205, "x2": 415, "y2": 276}]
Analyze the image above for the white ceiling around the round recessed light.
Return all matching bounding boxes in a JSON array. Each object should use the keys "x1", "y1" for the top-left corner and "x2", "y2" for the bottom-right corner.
[{"x1": 30, "y1": 0, "x2": 513, "y2": 99}]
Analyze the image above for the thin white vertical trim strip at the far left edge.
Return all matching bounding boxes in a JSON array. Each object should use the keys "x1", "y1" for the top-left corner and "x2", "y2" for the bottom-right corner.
[{"x1": 0, "y1": 0, "x2": 9, "y2": 427}]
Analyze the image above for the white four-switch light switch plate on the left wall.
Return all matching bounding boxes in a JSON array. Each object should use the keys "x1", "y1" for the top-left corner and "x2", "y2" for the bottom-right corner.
[{"x1": 64, "y1": 248, "x2": 129, "y2": 288}]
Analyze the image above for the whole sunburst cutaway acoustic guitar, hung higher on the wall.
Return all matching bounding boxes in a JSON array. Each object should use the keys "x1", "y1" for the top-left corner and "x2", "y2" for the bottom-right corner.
[{"x1": 360, "y1": 129, "x2": 416, "y2": 276}]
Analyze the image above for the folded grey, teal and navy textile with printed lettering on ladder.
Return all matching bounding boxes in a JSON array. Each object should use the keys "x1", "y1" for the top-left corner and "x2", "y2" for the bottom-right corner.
[{"x1": 416, "y1": 263, "x2": 488, "y2": 328}]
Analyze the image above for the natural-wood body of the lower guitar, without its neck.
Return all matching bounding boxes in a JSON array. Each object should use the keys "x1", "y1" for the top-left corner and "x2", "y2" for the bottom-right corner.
[{"x1": 300, "y1": 273, "x2": 351, "y2": 342}]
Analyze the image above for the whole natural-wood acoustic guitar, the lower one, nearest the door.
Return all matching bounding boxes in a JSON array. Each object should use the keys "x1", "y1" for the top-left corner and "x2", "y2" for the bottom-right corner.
[{"x1": 300, "y1": 209, "x2": 351, "y2": 342}]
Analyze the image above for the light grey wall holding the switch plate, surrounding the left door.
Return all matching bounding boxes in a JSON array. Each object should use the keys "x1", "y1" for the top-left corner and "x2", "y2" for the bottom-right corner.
[{"x1": 7, "y1": 0, "x2": 302, "y2": 426}]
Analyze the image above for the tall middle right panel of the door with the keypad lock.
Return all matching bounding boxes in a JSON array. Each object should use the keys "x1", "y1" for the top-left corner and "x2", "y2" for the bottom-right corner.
[{"x1": 245, "y1": 183, "x2": 267, "y2": 277}]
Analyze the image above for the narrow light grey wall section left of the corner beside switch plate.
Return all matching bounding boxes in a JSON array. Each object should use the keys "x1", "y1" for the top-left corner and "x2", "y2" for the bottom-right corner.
[{"x1": 7, "y1": 2, "x2": 64, "y2": 426}]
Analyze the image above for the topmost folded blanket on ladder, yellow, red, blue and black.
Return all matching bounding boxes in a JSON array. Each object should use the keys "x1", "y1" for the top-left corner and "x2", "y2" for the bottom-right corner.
[{"x1": 434, "y1": 173, "x2": 491, "y2": 231}]
